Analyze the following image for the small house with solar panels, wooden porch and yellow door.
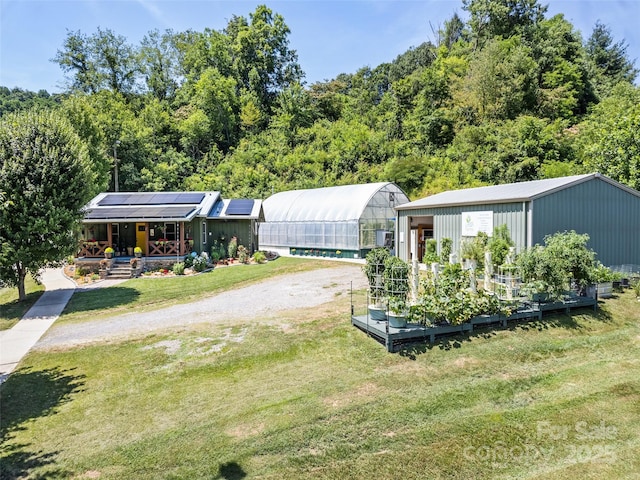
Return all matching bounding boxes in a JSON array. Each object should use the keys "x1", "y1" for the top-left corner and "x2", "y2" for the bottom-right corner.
[{"x1": 78, "y1": 192, "x2": 264, "y2": 259}]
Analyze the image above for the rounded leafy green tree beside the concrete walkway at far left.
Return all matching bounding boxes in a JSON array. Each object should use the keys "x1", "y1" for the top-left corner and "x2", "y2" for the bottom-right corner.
[{"x1": 0, "y1": 111, "x2": 91, "y2": 300}]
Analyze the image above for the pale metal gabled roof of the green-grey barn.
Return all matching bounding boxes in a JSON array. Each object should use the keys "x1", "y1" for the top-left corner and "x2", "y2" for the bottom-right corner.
[{"x1": 396, "y1": 173, "x2": 640, "y2": 210}]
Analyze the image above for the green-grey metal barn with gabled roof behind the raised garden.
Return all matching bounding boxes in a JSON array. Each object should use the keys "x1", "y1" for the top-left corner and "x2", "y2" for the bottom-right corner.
[{"x1": 396, "y1": 173, "x2": 640, "y2": 266}]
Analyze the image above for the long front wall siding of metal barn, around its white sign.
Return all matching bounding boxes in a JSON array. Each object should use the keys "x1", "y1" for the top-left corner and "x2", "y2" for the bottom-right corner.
[{"x1": 396, "y1": 202, "x2": 528, "y2": 260}]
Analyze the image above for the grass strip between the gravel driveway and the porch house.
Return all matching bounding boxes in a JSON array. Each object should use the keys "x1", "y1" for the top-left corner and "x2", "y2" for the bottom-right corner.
[{"x1": 57, "y1": 257, "x2": 339, "y2": 324}]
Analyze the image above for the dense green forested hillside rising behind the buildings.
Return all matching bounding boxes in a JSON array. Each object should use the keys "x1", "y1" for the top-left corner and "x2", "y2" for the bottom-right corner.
[{"x1": 0, "y1": 0, "x2": 640, "y2": 198}]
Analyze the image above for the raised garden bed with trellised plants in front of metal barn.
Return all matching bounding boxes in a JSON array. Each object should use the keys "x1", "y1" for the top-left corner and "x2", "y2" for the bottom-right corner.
[{"x1": 354, "y1": 225, "x2": 640, "y2": 347}]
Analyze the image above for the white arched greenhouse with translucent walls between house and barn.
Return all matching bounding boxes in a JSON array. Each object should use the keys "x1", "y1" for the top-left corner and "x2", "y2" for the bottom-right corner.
[{"x1": 259, "y1": 182, "x2": 409, "y2": 258}]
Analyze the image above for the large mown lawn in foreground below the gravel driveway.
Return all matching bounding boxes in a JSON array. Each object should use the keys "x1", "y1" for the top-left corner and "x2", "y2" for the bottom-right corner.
[{"x1": 0, "y1": 280, "x2": 640, "y2": 479}]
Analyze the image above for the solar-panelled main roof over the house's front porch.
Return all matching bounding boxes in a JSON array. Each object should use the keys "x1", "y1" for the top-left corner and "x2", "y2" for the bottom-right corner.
[{"x1": 84, "y1": 192, "x2": 220, "y2": 223}]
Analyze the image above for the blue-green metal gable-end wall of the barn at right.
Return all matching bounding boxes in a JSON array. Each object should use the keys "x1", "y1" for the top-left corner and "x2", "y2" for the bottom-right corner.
[{"x1": 532, "y1": 178, "x2": 640, "y2": 265}]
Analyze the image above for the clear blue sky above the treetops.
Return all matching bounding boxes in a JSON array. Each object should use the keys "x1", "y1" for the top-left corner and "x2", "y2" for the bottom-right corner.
[{"x1": 0, "y1": 0, "x2": 640, "y2": 92}]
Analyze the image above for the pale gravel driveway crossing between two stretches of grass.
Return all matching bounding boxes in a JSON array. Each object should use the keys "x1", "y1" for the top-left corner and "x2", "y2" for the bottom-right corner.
[{"x1": 34, "y1": 264, "x2": 367, "y2": 349}]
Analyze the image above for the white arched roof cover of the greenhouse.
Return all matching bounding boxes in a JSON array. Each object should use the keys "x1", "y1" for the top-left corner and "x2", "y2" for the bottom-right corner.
[{"x1": 263, "y1": 182, "x2": 409, "y2": 222}]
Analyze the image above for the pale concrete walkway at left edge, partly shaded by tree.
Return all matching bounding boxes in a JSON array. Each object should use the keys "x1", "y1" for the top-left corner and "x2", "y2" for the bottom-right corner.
[{"x1": 0, "y1": 268, "x2": 76, "y2": 383}]
